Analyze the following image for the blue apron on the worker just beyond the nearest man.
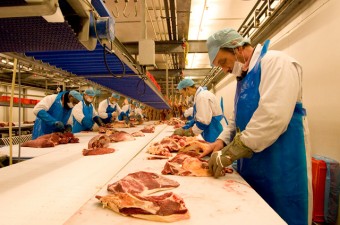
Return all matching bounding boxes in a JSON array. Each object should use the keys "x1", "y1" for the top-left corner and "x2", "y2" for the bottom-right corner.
[{"x1": 192, "y1": 87, "x2": 227, "y2": 142}]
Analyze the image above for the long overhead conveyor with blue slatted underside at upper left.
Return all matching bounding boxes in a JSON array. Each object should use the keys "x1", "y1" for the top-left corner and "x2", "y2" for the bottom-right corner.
[{"x1": 0, "y1": 0, "x2": 169, "y2": 109}]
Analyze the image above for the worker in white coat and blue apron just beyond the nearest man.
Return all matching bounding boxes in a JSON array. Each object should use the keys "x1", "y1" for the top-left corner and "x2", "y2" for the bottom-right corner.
[{"x1": 174, "y1": 78, "x2": 227, "y2": 142}]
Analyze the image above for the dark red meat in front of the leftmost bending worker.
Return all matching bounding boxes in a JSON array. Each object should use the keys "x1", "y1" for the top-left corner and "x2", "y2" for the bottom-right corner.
[{"x1": 21, "y1": 132, "x2": 79, "y2": 148}]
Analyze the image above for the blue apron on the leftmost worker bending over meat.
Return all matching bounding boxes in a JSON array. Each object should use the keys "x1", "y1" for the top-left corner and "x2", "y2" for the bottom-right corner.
[{"x1": 32, "y1": 91, "x2": 72, "y2": 140}]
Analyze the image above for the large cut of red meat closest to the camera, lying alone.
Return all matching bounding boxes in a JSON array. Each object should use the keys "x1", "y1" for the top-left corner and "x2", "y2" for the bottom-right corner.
[{"x1": 96, "y1": 171, "x2": 190, "y2": 222}]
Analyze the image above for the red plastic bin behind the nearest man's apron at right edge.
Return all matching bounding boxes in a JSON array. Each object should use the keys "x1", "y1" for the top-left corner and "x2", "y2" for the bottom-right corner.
[{"x1": 312, "y1": 158, "x2": 327, "y2": 223}]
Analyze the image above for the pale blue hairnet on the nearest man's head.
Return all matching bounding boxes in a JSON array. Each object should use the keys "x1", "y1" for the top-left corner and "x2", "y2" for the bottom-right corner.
[{"x1": 207, "y1": 28, "x2": 250, "y2": 66}]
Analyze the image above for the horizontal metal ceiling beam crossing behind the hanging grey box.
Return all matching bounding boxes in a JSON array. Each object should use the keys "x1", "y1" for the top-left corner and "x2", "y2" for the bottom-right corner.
[{"x1": 122, "y1": 41, "x2": 208, "y2": 55}]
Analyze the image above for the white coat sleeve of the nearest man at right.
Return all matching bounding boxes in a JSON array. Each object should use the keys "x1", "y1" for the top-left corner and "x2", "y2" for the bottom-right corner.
[{"x1": 241, "y1": 51, "x2": 301, "y2": 152}]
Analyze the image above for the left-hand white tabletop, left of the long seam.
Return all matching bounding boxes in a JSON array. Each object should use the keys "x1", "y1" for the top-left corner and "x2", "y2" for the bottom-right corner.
[{"x1": 0, "y1": 125, "x2": 167, "y2": 225}]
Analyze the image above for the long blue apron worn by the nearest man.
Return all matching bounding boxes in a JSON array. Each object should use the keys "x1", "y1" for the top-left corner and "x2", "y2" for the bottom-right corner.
[{"x1": 235, "y1": 41, "x2": 308, "y2": 225}]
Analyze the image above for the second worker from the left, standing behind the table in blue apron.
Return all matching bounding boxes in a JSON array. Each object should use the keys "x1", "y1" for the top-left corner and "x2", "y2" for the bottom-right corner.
[{"x1": 72, "y1": 89, "x2": 105, "y2": 133}]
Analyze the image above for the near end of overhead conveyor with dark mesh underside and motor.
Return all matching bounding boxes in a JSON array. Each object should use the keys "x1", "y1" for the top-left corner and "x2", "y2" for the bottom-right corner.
[{"x1": 0, "y1": 0, "x2": 114, "y2": 52}]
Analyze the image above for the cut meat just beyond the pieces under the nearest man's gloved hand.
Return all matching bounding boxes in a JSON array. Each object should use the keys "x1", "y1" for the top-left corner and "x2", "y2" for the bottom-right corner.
[{"x1": 147, "y1": 135, "x2": 209, "y2": 158}]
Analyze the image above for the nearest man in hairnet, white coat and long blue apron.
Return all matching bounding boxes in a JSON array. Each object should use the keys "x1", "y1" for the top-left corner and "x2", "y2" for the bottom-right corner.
[{"x1": 201, "y1": 28, "x2": 312, "y2": 225}]
